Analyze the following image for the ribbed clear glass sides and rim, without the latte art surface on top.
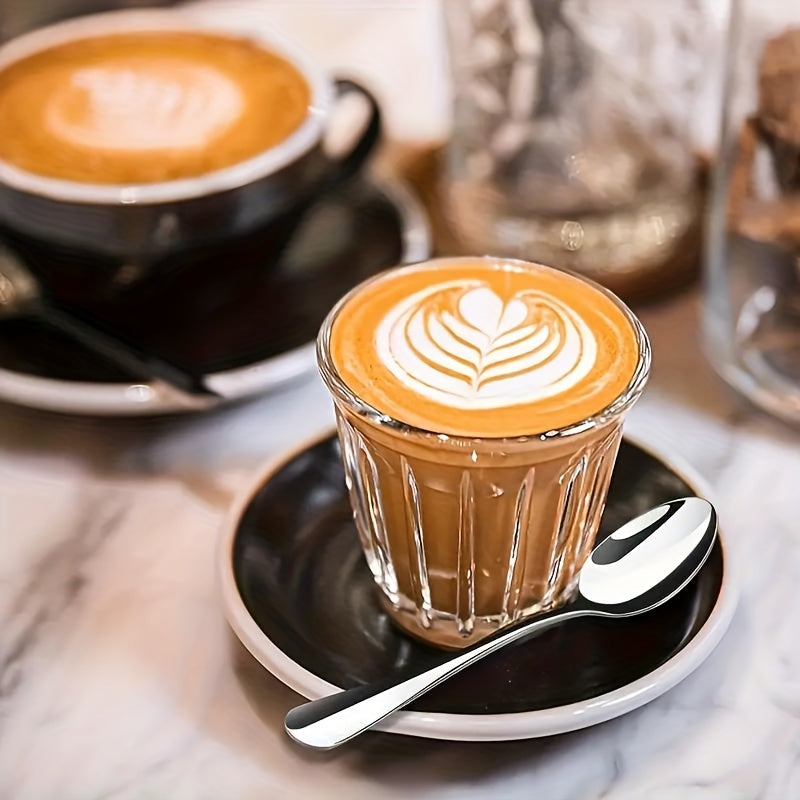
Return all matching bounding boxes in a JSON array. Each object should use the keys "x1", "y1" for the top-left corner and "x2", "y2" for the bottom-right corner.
[{"x1": 317, "y1": 265, "x2": 650, "y2": 648}]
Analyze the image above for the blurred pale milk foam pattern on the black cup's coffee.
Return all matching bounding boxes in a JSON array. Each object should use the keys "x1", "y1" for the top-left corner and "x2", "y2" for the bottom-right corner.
[{"x1": 45, "y1": 58, "x2": 244, "y2": 152}]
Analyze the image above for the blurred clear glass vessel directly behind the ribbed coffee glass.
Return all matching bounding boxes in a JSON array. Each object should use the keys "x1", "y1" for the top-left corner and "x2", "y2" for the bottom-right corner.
[{"x1": 441, "y1": 0, "x2": 714, "y2": 299}]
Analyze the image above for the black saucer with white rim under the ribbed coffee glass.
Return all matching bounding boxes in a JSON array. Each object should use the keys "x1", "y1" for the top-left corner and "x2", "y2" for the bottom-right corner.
[{"x1": 219, "y1": 434, "x2": 735, "y2": 741}]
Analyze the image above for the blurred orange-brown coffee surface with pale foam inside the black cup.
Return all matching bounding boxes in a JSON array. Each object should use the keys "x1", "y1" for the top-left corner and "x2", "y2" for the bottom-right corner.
[{"x1": 0, "y1": 31, "x2": 311, "y2": 184}]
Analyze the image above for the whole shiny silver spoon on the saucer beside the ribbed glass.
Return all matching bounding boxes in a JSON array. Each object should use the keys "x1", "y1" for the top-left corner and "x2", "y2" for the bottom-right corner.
[{"x1": 284, "y1": 497, "x2": 717, "y2": 750}]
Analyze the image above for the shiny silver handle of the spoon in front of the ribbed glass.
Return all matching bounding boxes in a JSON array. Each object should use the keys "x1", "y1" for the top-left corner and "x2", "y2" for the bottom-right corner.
[{"x1": 284, "y1": 608, "x2": 592, "y2": 750}]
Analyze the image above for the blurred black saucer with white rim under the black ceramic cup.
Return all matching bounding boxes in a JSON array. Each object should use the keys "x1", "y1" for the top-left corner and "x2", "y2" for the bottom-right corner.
[{"x1": 0, "y1": 178, "x2": 430, "y2": 415}]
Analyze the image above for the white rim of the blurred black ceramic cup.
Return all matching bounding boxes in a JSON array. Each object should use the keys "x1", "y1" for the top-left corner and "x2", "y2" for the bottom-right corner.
[{"x1": 0, "y1": 8, "x2": 333, "y2": 205}]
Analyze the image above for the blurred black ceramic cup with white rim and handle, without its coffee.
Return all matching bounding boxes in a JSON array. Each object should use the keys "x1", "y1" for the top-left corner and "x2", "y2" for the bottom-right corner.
[{"x1": 0, "y1": 9, "x2": 381, "y2": 309}]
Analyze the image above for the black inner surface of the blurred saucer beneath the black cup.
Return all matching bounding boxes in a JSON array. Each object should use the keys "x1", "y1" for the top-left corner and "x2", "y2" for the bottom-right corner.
[{"x1": 0, "y1": 179, "x2": 428, "y2": 388}]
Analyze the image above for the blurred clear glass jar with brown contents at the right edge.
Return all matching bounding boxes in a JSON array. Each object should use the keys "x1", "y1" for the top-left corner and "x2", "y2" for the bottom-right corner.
[{"x1": 704, "y1": 0, "x2": 800, "y2": 422}]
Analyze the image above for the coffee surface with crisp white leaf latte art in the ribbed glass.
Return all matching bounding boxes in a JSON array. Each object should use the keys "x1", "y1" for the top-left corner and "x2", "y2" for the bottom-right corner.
[{"x1": 330, "y1": 258, "x2": 639, "y2": 437}]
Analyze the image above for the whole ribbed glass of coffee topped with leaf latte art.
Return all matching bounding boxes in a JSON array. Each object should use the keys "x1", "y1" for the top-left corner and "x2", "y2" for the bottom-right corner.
[{"x1": 317, "y1": 257, "x2": 650, "y2": 648}]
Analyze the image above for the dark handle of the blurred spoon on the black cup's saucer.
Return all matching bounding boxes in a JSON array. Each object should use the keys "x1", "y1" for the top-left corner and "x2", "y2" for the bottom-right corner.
[{"x1": 35, "y1": 300, "x2": 222, "y2": 405}]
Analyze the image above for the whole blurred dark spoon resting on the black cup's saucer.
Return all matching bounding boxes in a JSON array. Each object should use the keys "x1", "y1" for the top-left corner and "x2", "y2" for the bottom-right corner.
[{"x1": 0, "y1": 247, "x2": 222, "y2": 409}]
